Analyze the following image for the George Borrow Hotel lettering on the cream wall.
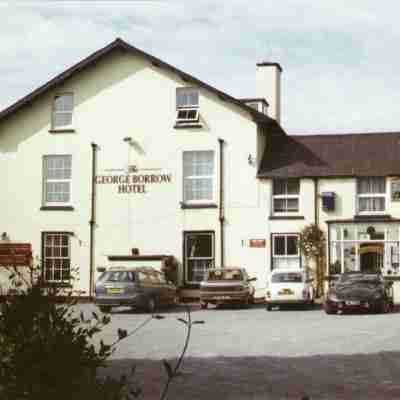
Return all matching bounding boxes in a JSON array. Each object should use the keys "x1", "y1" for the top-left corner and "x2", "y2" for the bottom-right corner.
[{"x1": 95, "y1": 165, "x2": 172, "y2": 193}]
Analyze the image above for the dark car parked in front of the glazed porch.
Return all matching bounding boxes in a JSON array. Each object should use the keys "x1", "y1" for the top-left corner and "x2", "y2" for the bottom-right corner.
[{"x1": 324, "y1": 272, "x2": 393, "y2": 314}]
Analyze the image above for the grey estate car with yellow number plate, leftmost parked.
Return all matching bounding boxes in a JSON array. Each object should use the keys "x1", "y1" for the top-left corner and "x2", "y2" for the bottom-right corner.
[{"x1": 95, "y1": 267, "x2": 178, "y2": 312}]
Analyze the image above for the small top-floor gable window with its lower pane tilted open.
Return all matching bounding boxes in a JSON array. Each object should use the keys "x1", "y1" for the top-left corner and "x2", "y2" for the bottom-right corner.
[{"x1": 176, "y1": 88, "x2": 199, "y2": 124}]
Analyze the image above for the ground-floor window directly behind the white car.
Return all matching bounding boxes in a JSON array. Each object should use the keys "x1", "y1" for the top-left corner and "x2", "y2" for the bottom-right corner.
[{"x1": 272, "y1": 233, "x2": 301, "y2": 269}]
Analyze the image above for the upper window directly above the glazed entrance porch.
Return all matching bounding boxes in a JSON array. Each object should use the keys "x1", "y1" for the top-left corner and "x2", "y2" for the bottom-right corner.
[{"x1": 357, "y1": 178, "x2": 386, "y2": 213}]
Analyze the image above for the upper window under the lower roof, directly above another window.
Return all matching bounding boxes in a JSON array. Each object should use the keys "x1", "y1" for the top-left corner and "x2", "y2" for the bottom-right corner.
[{"x1": 273, "y1": 179, "x2": 300, "y2": 213}]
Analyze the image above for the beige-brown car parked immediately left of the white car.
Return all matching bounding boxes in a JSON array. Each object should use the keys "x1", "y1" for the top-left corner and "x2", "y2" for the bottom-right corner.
[{"x1": 200, "y1": 267, "x2": 257, "y2": 308}]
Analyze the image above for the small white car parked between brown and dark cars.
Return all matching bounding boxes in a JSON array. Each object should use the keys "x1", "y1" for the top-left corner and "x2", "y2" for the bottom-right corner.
[{"x1": 265, "y1": 269, "x2": 314, "y2": 311}]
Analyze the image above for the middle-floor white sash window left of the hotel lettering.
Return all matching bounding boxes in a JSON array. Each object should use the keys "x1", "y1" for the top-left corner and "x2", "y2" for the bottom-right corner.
[{"x1": 43, "y1": 155, "x2": 72, "y2": 206}]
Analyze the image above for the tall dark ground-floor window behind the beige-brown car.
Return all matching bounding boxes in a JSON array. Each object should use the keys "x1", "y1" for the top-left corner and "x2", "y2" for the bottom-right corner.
[{"x1": 184, "y1": 231, "x2": 215, "y2": 283}]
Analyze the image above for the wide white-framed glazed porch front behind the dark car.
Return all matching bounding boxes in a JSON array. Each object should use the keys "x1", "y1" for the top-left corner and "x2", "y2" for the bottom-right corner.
[{"x1": 329, "y1": 223, "x2": 400, "y2": 275}]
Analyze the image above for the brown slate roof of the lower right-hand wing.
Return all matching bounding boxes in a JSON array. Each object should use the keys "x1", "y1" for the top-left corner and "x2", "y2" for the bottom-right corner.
[{"x1": 258, "y1": 132, "x2": 400, "y2": 178}]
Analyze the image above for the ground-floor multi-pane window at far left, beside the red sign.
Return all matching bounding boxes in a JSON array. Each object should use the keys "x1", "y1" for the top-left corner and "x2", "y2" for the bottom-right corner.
[{"x1": 42, "y1": 232, "x2": 71, "y2": 282}]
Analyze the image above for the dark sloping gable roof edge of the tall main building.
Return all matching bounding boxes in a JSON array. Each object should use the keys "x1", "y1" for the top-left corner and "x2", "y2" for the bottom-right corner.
[{"x1": 0, "y1": 38, "x2": 285, "y2": 134}]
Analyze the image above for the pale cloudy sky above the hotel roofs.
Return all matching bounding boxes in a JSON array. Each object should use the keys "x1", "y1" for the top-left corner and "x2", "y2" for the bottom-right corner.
[{"x1": 0, "y1": 0, "x2": 400, "y2": 134}]
